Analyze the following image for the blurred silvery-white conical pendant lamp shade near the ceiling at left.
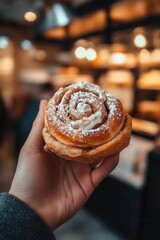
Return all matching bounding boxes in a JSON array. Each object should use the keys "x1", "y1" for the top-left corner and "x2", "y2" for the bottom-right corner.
[{"x1": 36, "y1": 3, "x2": 73, "y2": 34}]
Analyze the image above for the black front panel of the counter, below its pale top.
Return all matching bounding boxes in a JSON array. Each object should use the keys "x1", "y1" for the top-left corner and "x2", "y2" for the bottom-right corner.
[{"x1": 86, "y1": 172, "x2": 143, "y2": 240}]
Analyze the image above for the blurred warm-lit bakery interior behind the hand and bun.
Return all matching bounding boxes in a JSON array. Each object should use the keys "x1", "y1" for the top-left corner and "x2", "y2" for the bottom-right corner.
[{"x1": 0, "y1": 0, "x2": 160, "y2": 239}]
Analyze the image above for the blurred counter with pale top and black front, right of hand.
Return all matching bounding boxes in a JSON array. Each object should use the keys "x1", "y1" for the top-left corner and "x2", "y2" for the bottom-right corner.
[{"x1": 86, "y1": 134, "x2": 159, "y2": 240}]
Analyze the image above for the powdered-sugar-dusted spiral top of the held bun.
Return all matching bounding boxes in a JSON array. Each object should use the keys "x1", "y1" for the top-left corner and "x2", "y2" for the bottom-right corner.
[{"x1": 46, "y1": 82, "x2": 123, "y2": 142}]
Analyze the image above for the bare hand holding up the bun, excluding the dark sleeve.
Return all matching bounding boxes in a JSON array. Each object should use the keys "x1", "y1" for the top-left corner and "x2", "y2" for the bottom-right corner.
[{"x1": 9, "y1": 100, "x2": 119, "y2": 230}]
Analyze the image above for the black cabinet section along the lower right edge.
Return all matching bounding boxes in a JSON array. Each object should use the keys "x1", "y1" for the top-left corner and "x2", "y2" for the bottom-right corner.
[{"x1": 139, "y1": 148, "x2": 160, "y2": 240}]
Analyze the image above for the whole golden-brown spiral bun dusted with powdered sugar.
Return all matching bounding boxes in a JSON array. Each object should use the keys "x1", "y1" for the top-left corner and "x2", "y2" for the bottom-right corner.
[{"x1": 43, "y1": 82, "x2": 131, "y2": 163}]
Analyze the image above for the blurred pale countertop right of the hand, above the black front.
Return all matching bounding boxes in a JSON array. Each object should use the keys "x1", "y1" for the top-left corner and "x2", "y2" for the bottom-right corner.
[{"x1": 111, "y1": 134, "x2": 154, "y2": 184}]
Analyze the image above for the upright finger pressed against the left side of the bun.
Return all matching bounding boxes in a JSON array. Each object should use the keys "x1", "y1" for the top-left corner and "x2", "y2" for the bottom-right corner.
[{"x1": 25, "y1": 100, "x2": 47, "y2": 149}]
